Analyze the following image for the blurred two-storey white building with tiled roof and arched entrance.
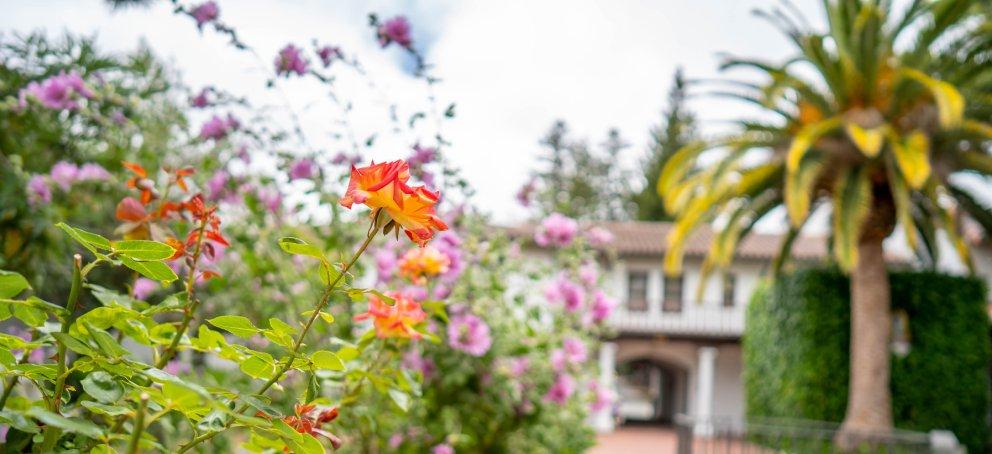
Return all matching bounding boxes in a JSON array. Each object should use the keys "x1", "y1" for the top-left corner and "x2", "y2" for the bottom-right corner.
[{"x1": 517, "y1": 222, "x2": 827, "y2": 431}]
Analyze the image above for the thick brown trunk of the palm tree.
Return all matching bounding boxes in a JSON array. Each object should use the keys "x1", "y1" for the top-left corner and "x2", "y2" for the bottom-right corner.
[{"x1": 838, "y1": 235, "x2": 892, "y2": 448}]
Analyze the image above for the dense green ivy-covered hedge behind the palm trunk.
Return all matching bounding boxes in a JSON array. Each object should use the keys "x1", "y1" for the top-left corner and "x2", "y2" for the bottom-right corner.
[{"x1": 743, "y1": 270, "x2": 992, "y2": 452}]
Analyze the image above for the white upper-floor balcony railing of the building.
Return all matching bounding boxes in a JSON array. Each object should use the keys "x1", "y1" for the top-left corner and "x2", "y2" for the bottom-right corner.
[{"x1": 609, "y1": 303, "x2": 744, "y2": 337}]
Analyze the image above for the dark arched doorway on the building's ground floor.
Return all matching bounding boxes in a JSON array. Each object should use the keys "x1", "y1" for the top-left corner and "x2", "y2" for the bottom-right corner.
[{"x1": 617, "y1": 358, "x2": 688, "y2": 424}]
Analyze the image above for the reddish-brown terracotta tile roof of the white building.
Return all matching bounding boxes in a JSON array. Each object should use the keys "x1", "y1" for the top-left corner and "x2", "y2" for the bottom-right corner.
[{"x1": 507, "y1": 221, "x2": 827, "y2": 260}]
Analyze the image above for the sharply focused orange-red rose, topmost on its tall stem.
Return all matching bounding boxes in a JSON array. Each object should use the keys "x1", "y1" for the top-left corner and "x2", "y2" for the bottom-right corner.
[{"x1": 341, "y1": 160, "x2": 448, "y2": 246}]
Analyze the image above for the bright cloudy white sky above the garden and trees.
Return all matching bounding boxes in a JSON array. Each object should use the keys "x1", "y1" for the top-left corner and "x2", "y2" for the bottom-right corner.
[{"x1": 0, "y1": 0, "x2": 823, "y2": 224}]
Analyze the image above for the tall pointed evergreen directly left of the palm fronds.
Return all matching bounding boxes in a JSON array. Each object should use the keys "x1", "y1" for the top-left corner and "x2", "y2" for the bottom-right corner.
[{"x1": 634, "y1": 68, "x2": 696, "y2": 221}]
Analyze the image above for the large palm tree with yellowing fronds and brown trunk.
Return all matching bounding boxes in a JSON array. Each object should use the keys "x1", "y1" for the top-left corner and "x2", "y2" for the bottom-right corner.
[{"x1": 658, "y1": 0, "x2": 992, "y2": 435}]
